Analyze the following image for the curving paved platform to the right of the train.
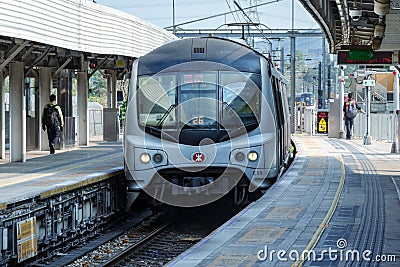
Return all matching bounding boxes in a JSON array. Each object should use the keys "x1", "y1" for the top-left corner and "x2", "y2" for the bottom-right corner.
[{"x1": 168, "y1": 136, "x2": 400, "y2": 267}]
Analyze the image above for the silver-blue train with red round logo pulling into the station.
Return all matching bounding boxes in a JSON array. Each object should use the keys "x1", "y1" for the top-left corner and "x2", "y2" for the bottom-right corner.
[{"x1": 124, "y1": 36, "x2": 291, "y2": 208}]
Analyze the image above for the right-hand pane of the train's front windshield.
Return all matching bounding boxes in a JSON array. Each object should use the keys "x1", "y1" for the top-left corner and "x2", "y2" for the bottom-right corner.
[{"x1": 221, "y1": 72, "x2": 261, "y2": 128}]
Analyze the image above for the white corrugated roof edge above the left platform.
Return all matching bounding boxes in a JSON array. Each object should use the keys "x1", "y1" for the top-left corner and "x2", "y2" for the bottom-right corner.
[{"x1": 0, "y1": 0, "x2": 176, "y2": 57}]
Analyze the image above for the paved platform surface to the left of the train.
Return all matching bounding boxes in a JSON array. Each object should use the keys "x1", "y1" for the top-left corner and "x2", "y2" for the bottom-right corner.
[{"x1": 0, "y1": 141, "x2": 123, "y2": 207}]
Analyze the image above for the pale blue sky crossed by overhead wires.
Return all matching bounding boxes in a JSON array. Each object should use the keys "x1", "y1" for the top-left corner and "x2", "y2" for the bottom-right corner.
[{"x1": 95, "y1": 0, "x2": 319, "y2": 29}]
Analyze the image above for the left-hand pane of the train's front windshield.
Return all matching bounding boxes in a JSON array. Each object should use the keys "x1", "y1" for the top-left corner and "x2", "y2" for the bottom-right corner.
[{"x1": 137, "y1": 74, "x2": 177, "y2": 127}]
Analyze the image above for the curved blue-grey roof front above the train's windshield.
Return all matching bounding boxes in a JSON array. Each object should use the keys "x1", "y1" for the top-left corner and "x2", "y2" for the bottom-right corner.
[{"x1": 138, "y1": 37, "x2": 268, "y2": 75}]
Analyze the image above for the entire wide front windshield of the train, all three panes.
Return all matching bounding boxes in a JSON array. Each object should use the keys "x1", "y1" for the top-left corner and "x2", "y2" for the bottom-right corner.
[{"x1": 137, "y1": 71, "x2": 261, "y2": 130}]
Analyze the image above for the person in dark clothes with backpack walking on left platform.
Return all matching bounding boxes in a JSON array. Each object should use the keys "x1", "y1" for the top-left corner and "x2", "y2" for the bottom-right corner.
[{"x1": 42, "y1": 94, "x2": 64, "y2": 154}]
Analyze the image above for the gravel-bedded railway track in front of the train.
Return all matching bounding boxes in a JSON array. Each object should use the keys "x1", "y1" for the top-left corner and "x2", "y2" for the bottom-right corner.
[{"x1": 63, "y1": 202, "x2": 239, "y2": 267}]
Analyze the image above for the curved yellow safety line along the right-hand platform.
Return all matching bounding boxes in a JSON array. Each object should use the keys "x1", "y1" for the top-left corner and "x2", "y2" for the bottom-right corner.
[{"x1": 292, "y1": 154, "x2": 346, "y2": 267}]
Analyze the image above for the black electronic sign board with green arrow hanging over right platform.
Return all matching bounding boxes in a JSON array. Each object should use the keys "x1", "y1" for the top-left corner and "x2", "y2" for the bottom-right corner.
[{"x1": 337, "y1": 50, "x2": 393, "y2": 65}]
